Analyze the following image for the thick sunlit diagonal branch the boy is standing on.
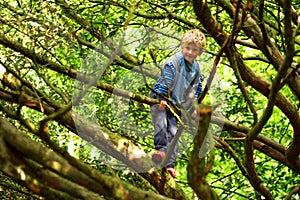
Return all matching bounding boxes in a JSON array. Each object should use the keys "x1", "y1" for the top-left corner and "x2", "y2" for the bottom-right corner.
[{"x1": 0, "y1": 76, "x2": 187, "y2": 199}]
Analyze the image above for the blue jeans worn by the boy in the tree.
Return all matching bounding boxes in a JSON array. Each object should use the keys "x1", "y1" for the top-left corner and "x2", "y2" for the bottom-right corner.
[{"x1": 151, "y1": 104, "x2": 178, "y2": 167}]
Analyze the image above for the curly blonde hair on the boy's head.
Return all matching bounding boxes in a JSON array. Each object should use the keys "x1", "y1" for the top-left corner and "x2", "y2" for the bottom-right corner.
[{"x1": 181, "y1": 29, "x2": 206, "y2": 47}]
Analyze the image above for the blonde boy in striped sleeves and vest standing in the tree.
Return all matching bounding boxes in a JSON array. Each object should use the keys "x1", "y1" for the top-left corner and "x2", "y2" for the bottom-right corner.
[{"x1": 150, "y1": 29, "x2": 206, "y2": 178}]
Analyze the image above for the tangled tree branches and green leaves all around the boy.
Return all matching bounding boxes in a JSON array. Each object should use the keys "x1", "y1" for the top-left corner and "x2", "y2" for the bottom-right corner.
[{"x1": 0, "y1": 0, "x2": 300, "y2": 199}]
